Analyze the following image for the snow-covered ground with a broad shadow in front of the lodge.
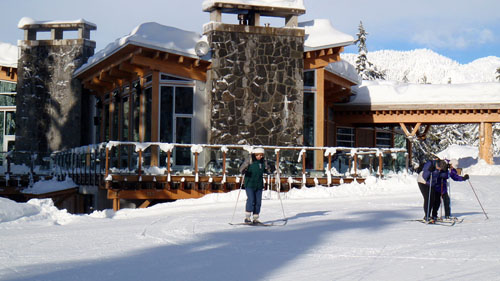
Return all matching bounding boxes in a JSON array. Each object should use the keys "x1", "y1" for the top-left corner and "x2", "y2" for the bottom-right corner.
[{"x1": 0, "y1": 147, "x2": 500, "y2": 281}]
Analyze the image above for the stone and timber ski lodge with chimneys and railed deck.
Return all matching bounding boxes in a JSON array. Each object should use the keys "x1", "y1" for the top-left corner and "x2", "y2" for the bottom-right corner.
[{"x1": 0, "y1": 1, "x2": 500, "y2": 212}]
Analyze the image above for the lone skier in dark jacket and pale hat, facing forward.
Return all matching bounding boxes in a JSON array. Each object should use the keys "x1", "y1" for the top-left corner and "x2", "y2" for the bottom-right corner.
[{"x1": 240, "y1": 148, "x2": 268, "y2": 223}]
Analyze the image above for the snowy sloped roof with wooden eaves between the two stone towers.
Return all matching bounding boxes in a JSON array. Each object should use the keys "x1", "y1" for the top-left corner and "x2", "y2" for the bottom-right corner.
[{"x1": 74, "y1": 23, "x2": 210, "y2": 93}]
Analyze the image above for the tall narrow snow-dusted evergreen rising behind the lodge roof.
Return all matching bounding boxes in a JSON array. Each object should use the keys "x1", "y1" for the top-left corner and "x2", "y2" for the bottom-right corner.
[{"x1": 354, "y1": 21, "x2": 385, "y2": 80}]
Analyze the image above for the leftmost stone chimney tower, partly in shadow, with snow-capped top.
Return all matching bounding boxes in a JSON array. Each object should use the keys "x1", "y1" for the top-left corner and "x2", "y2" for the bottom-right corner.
[{"x1": 16, "y1": 18, "x2": 96, "y2": 153}]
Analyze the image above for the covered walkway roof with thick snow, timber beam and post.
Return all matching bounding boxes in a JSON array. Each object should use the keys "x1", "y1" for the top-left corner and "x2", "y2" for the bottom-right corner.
[{"x1": 333, "y1": 81, "x2": 500, "y2": 163}]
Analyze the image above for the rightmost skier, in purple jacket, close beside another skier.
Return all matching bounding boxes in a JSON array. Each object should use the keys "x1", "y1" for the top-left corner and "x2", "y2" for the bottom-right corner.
[{"x1": 432, "y1": 159, "x2": 469, "y2": 219}]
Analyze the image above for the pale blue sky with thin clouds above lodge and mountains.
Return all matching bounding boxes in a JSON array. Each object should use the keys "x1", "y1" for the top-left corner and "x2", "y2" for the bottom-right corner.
[{"x1": 0, "y1": 0, "x2": 500, "y2": 64}]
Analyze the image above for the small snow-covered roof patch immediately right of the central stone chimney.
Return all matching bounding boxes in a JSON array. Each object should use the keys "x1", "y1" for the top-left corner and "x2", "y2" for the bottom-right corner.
[{"x1": 299, "y1": 19, "x2": 354, "y2": 52}]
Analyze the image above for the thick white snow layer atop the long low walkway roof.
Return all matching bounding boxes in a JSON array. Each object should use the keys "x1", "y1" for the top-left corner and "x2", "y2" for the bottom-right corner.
[{"x1": 345, "y1": 80, "x2": 500, "y2": 106}]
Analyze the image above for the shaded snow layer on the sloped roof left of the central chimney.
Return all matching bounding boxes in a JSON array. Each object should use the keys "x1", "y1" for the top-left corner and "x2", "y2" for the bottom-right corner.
[{"x1": 74, "y1": 22, "x2": 201, "y2": 75}]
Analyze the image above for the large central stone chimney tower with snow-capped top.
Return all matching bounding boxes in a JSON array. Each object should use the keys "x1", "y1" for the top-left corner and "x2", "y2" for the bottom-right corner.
[{"x1": 203, "y1": 0, "x2": 305, "y2": 146}]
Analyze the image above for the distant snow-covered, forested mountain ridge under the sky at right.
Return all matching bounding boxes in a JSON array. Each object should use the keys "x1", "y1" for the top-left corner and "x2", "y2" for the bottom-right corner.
[{"x1": 341, "y1": 49, "x2": 500, "y2": 84}]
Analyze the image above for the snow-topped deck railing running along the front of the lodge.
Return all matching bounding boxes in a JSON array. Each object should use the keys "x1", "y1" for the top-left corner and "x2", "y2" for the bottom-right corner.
[{"x1": 47, "y1": 141, "x2": 408, "y2": 188}]
